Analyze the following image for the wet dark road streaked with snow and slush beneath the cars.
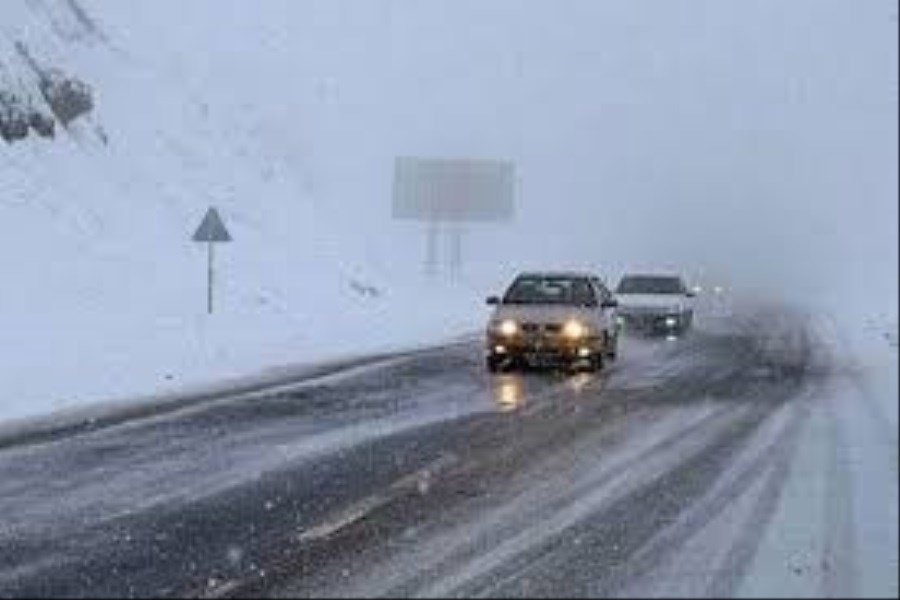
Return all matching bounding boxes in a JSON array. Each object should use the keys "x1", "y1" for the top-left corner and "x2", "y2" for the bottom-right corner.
[{"x1": 0, "y1": 312, "x2": 897, "y2": 597}]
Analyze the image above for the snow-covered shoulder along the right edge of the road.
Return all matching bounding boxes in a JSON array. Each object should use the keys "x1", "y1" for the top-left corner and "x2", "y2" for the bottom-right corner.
[{"x1": 738, "y1": 306, "x2": 900, "y2": 597}]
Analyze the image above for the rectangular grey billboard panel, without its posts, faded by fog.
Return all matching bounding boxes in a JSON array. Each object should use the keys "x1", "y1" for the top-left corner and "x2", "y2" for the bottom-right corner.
[{"x1": 393, "y1": 157, "x2": 515, "y2": 221}]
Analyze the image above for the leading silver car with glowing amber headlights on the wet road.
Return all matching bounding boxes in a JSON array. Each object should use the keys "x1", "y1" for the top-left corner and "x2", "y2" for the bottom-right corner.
[{"x1": 486, "y1": 272, "x2": 619, "y2": 373}]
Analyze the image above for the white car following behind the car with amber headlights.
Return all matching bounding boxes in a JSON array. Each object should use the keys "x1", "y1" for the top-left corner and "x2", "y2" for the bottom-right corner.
[{"x1": 616, "y1": 274, "x2": 696, "y2": 335}]
